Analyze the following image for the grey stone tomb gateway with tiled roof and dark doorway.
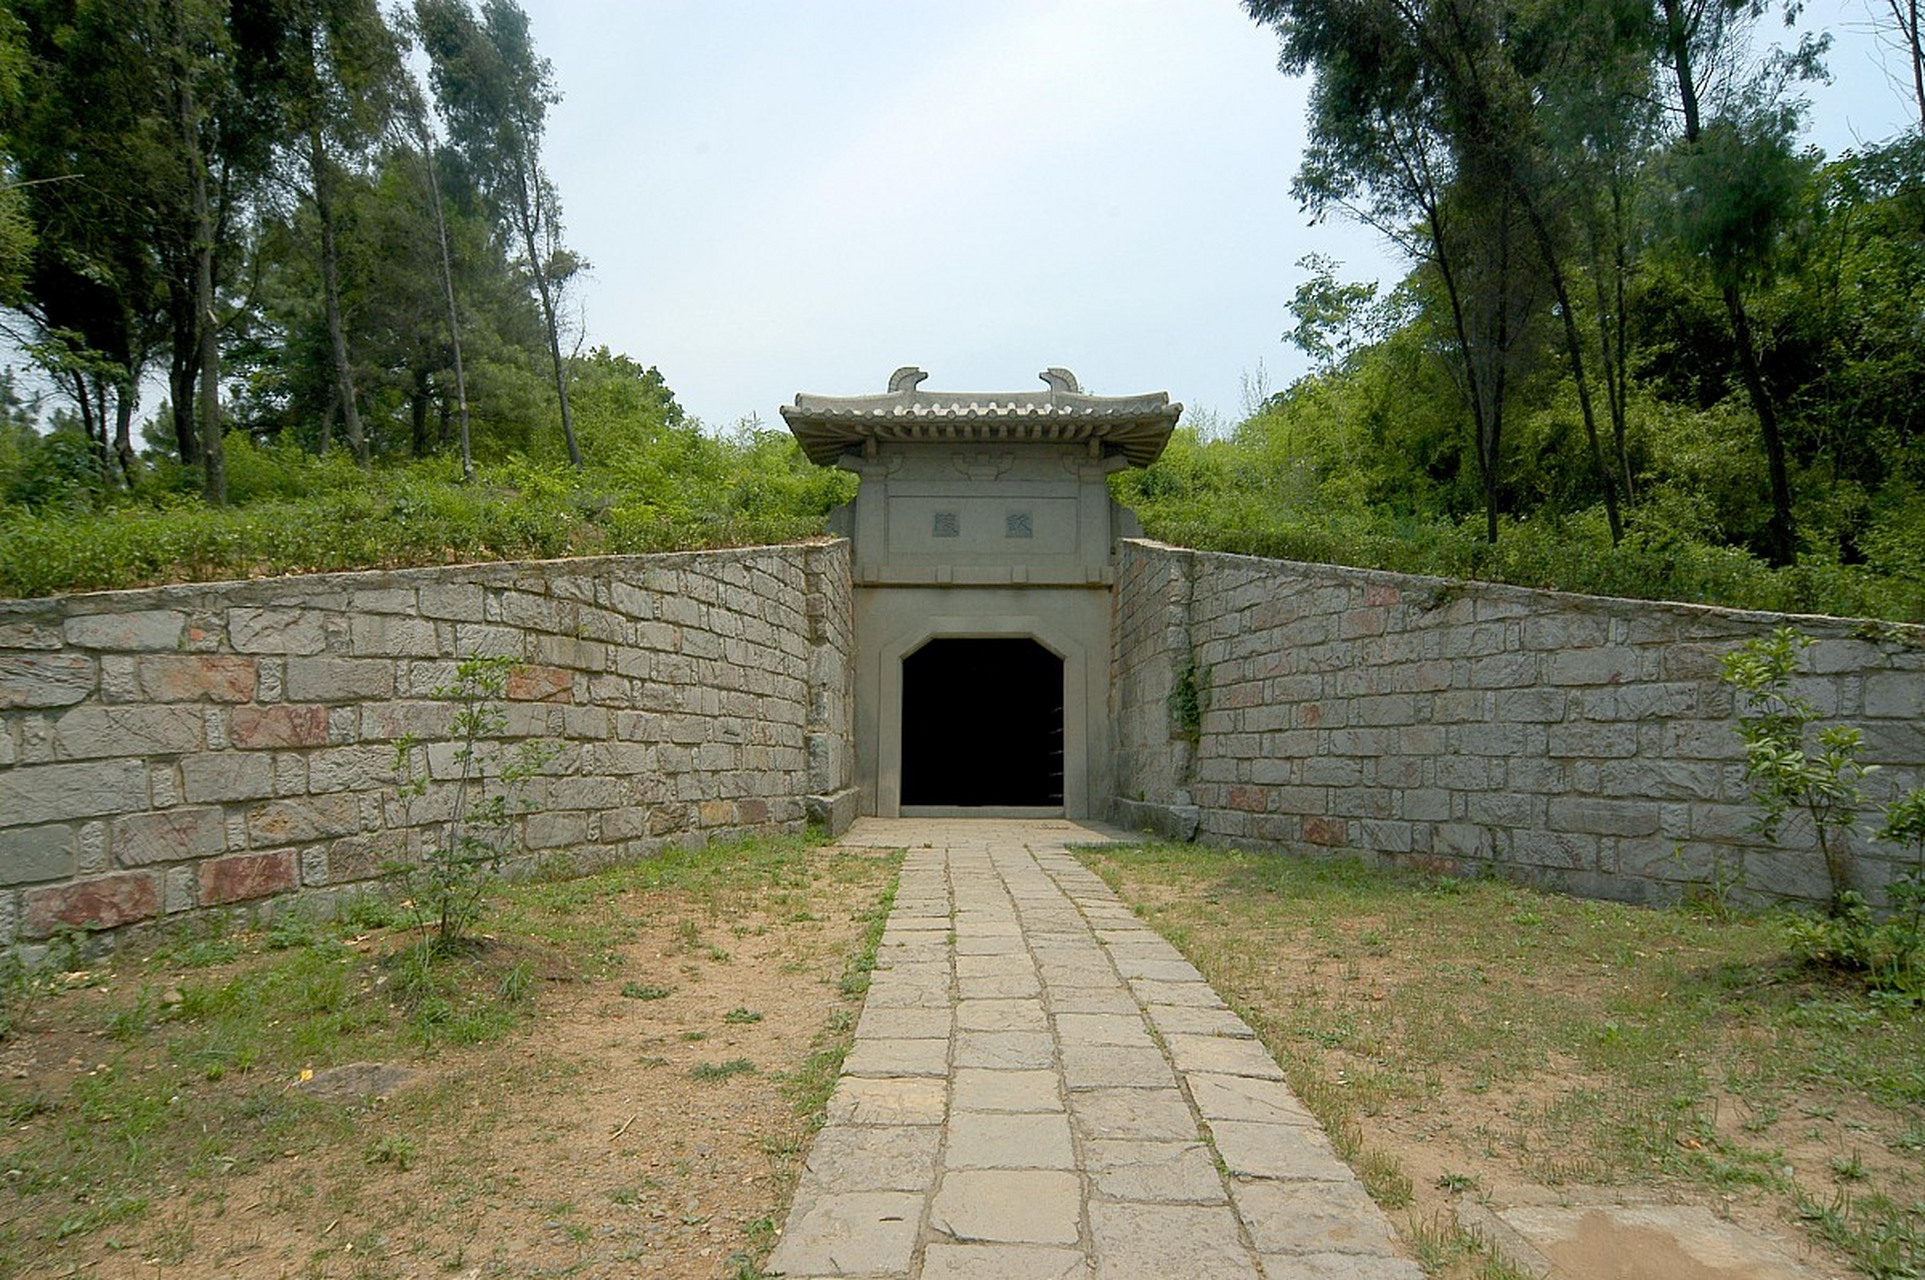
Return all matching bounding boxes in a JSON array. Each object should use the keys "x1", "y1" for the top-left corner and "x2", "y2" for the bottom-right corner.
[{"x1": 782, "y1": 368, "x2": 1182, "y2": 818}]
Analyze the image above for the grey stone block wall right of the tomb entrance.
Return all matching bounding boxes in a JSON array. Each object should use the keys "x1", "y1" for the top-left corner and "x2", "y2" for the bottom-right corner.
[{"x1": 1113, "y1": 543, "x2": 1925, "y2": 901}]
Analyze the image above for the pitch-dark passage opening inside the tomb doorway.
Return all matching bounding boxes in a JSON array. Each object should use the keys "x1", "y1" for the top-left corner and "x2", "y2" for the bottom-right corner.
[{"x1": 903, "y1": 639, "x2": 1063, "y2": 808}]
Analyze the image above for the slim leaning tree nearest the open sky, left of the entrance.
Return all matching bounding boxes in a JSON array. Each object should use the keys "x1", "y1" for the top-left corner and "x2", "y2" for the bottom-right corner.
[{"x1": 414, "y1": 0, "x2": 581, "y2": 468}]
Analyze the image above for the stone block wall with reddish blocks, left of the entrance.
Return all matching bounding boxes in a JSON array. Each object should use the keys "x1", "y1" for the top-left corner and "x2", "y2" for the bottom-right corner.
[{"x1": 0, "y1": 543, "x2": 853, "y2": 945}]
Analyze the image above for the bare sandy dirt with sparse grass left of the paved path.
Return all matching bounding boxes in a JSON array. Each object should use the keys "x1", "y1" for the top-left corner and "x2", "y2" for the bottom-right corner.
[{"x1": 0, "y1": 851, "x2": 893, "y2": 1280}]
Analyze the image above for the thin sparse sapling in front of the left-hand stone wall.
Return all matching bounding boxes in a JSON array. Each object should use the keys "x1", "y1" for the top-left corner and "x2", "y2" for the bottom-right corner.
[{"x1": 395, "y1": 654, "x2": 554, "y2": 955}]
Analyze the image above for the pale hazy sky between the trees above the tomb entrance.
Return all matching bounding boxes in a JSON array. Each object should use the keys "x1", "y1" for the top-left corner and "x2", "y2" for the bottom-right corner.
[{"x1": 522, "y1": 0, "x2": 1908, "y2": 427}]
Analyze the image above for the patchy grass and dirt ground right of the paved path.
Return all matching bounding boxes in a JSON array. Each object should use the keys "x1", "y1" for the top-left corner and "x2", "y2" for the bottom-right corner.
[{"x1": 1082, "y1": 845, "x2": 1925, "y2": 1276}]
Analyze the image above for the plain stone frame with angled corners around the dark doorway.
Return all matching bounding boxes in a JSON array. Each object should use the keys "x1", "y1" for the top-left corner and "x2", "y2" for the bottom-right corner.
[{"x1": 859, "y1": 614, "x2": 1109, "y2": 818}]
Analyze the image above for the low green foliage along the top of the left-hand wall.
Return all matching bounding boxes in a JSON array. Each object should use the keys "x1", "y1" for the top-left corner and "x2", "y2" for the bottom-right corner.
[{"x1": 0, "y1": 410, "x2": 855, "y2": 597}]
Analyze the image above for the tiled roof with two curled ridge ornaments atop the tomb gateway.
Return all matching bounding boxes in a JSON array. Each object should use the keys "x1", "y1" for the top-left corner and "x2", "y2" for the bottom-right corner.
[{"x1": 782, "y1": 366, "x2": 1184, "y2": 466}]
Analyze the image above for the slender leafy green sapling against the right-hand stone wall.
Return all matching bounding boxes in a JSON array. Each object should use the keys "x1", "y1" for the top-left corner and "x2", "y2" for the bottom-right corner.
[{"x1": 1721, "y1": 627, "x2": 1877, "y2": 918}]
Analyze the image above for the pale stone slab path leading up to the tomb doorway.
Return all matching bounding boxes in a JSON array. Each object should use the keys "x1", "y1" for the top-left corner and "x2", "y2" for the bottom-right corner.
[{"x1": 768, "y1": 818, "x2": 1421, "y2": 1280}]
